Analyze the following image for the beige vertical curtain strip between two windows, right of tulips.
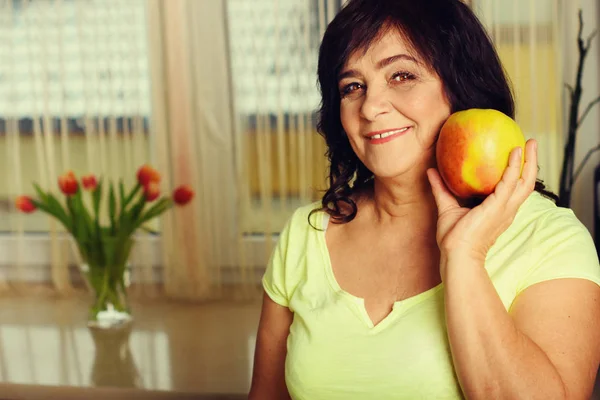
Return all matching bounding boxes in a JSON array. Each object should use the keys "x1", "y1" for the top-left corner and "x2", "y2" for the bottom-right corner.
[{"x1": 148, "y1": 0, "x2": 240, "y2": 299}]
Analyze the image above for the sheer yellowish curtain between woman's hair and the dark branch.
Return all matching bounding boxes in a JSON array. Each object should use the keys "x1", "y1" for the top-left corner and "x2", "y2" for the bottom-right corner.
[{"x1": 471, "y1": 0, "x2": 564, "y2": 193}]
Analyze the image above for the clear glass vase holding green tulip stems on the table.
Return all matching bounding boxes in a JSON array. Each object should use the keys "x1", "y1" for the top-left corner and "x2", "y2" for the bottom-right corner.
[{"x1": 77, "y1": 236, "x2": 133, "y2": 328}]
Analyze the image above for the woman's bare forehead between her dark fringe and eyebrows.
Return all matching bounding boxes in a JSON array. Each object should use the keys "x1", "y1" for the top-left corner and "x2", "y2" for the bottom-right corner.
[{"x1": 344, "y1": 28, "x2": 423, "y2": 69}]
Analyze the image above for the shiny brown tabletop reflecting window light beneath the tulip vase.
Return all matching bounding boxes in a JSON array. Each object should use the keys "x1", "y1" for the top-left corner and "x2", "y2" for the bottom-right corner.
[{"x1": 0, "y1": 296, "x2": 260, "y2": 399}]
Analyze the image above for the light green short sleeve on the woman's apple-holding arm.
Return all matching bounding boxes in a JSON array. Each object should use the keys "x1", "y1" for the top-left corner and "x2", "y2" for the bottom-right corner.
[{"x1": 486, "y1": 192, "x2": 600, "y2": 307}]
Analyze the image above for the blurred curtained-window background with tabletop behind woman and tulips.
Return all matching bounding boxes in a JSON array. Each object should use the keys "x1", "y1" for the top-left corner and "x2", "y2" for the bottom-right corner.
[{"x1": 0, "y1": 0, "x2": 600, "y2": 398}]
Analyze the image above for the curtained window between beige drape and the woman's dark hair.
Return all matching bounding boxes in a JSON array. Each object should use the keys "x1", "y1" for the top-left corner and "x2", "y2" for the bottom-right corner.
[{"x1": 227, "y1": 0, "x2": 340, "y2": 235}]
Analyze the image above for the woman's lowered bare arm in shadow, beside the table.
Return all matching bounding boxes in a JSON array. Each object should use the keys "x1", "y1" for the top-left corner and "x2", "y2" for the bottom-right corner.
[{"x1": 248, "y1": 293, "x2": 293, "y2": 400}]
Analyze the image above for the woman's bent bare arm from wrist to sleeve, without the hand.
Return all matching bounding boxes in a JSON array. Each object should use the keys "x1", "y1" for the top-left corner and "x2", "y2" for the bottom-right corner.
[{"x1": 445, "y1": 252, "x2": 600, "y2": 400}]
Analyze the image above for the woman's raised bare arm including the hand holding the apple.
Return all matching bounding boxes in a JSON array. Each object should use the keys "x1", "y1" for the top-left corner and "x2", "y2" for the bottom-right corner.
[{"x1": 428, "y1": 140, "x2": 600, "y2": 400}]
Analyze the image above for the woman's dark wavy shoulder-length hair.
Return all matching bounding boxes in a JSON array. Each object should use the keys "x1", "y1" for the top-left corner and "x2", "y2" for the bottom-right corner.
[{"x1": 309, "y1": 0, "x2": 558, "y2": 223}]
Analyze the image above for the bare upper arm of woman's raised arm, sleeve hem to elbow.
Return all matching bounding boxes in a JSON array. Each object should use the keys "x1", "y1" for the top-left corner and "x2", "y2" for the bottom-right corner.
[{"x1": 510, "y1": 279, "x2": 600, "y2": 400}]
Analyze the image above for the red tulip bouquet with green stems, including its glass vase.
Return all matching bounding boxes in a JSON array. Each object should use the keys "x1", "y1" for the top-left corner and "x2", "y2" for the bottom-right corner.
[{"x1": 15, "y1": 165, "x2": 194, "y2": 324}]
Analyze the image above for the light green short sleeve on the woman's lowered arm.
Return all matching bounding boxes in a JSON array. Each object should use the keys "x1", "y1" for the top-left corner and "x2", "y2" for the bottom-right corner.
[{"x1": 262, "y1": 216, "x2": 291, "y2": 307}]
